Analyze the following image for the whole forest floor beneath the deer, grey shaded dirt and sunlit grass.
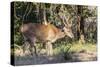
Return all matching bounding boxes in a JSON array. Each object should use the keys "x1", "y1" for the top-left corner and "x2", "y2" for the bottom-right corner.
[{"x1": 15, "y1": 44, "x2": 97, "y2": 66}]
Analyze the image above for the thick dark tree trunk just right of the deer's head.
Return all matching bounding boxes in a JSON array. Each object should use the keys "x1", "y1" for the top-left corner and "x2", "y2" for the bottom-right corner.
[{"x1": 77, "y1": 5, "x2": 85, "y2": 43}]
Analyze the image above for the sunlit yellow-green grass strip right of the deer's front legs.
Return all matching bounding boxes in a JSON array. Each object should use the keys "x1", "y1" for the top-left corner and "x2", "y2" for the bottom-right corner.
[{"x1": 54, "y1": 42, "x2": 97, "y2": 55}]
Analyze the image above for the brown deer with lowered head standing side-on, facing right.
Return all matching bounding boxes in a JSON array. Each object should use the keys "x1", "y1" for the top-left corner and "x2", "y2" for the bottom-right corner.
[{"x1": 20, "y1": 18, "x2": 74, "y2": 55}]
